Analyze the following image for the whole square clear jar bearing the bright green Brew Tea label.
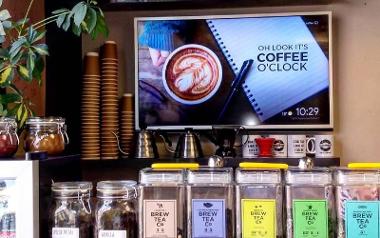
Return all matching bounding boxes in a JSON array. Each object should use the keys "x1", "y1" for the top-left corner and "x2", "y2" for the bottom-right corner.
[{"x1": 285, "y1": 168, "x2": 336, "y2": 238}]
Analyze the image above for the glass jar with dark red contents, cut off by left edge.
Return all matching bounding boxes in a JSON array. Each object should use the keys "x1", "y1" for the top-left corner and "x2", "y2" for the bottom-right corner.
[{"x1": 0, "y1": 117, "x2": 19, "y2": 158}]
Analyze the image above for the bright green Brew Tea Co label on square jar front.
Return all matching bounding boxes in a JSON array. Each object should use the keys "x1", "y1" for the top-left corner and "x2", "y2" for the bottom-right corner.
[{"x1": 293, "y1": 200, "x2": 329, "y2": 238}]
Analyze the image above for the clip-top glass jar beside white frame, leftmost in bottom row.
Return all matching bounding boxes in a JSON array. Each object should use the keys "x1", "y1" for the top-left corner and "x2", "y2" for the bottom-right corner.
[{"x1": 50, "y1": 182, "x2": 93, "y2": 238}]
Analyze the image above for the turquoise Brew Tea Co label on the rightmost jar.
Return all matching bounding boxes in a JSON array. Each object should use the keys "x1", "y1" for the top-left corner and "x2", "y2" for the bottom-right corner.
[{"x1": 345, "y1": 201, "x2": 379, "y2": 238}]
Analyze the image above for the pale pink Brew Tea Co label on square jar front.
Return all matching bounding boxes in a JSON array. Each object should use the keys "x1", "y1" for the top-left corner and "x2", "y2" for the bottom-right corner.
[{"x1": 143, "y1": 200, "x2": 177, "y2": 238}]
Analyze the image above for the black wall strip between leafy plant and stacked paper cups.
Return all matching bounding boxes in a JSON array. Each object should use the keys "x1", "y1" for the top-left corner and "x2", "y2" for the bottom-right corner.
[{"x1": 45, "y1": 0, "x2": 82, "y2": 154}]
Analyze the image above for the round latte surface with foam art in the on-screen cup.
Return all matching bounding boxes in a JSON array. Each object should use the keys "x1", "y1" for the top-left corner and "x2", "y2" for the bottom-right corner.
[{"x1": 166, "y1": 48, "x2": 220, "y2": 100}]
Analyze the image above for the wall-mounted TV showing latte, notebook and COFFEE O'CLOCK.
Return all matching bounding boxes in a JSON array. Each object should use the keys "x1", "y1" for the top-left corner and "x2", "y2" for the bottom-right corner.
[{"x1": 135, "y1": 12, "x2": 333, "y2": 130}]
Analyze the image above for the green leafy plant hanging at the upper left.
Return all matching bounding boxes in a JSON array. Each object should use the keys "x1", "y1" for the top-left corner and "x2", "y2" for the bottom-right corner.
[{"x1": 0, "y1": 0, "x2": 108, "y2": 129}]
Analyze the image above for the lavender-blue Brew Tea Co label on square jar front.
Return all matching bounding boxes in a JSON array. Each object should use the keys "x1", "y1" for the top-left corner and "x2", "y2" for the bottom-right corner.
[{"x1": 192, "y1": 199, "x2": 226, "y2": 238}]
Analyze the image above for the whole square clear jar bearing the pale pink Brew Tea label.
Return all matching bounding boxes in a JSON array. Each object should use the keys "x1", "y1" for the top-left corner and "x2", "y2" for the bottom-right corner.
[{"x1": 139, "y1": 168, "x2": 186, "y2": 238}]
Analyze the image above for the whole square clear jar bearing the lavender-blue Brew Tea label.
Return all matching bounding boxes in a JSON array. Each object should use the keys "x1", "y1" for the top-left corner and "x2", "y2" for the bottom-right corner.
[{"x1": 187, "y1": 168, "x2": 235, "y2": 238}]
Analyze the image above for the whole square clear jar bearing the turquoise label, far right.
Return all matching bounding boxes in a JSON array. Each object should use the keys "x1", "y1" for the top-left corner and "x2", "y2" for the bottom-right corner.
[{"x1": 334, "y1": 165, "x2": 380, "y2": 238}]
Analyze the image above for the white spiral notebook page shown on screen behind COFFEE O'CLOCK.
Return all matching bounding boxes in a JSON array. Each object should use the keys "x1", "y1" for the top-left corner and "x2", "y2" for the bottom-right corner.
[{"x1": 206, "y1": 16, "x2": 329, "y2": 122}]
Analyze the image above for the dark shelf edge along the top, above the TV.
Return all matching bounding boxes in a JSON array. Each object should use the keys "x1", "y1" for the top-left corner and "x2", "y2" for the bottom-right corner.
[{"x1": 101, "y1": 0, "x2": 332, "y2": 11}]
